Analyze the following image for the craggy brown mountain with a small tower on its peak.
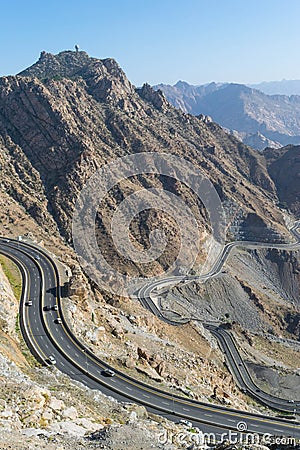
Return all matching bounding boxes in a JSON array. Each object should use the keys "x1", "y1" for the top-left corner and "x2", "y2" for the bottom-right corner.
[{"x1": 0, "y1": 51, "x2": 283, "y2": 282}]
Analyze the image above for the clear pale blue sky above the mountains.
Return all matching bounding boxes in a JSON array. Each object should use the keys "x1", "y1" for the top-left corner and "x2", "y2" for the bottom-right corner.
[{"x1": 0, "y1": 0, "x2": 300, "y2": 85}]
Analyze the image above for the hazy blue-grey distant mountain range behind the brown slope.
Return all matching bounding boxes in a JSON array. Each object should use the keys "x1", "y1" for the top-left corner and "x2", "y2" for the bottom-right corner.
[{"x1": 154, "y1": 81, "x2": 300, "y2": 150}]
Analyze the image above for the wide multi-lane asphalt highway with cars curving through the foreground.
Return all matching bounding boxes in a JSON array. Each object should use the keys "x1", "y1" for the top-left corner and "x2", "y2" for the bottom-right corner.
[{"x1": 0, "y1": 224, "x2": 300, "y2": 439}]
